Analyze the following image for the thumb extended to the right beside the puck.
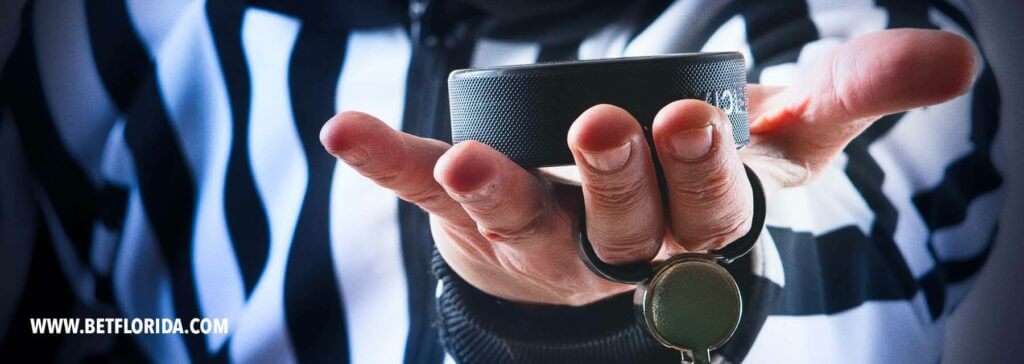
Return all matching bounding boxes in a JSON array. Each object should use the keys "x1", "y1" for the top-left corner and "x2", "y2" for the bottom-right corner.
[{"x1": 751, "y1": 29, "x2": 979, "y2": 138}]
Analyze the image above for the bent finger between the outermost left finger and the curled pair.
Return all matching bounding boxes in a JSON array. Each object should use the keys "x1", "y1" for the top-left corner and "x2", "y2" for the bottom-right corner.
[{"x1": 434, "y1": 140, "x2": 571, "y2": 247}]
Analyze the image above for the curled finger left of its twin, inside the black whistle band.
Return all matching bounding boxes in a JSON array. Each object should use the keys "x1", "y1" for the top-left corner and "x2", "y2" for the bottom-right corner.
[{"x1": 568, "y1": 105, "x2": 665, "y2": 264}]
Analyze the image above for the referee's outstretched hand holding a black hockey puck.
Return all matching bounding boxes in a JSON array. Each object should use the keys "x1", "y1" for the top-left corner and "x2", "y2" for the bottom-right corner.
[{"x1": 321, "y1": 30, "x2": 978, "y2": 306}]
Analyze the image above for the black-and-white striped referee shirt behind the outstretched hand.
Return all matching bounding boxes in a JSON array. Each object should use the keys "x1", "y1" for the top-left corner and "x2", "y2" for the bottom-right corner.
[{"x1": 0, "y1": 0, "x2": 1005, "y2": 363}]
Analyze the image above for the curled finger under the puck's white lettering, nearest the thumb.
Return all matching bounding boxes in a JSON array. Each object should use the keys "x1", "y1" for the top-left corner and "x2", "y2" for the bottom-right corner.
[{"x1": 652, "y1": 99, "x2": 754, "y2": 251}]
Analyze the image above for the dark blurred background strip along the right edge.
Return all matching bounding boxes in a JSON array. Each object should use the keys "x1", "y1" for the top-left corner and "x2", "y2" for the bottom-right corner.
[{"x1": 943, "y1": 0, "x2": 1024, "y2": 363}]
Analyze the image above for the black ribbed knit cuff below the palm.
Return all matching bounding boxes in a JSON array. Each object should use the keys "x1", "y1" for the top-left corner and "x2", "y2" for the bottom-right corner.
[{"x1": 431, "y1": 250, "x2": 679, "y2": 363}]
